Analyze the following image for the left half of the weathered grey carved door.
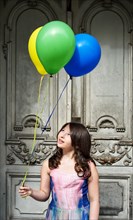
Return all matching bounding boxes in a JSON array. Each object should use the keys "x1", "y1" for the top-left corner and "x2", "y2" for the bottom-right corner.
[{"x1": 0, "y1": 1, "x2": 71, "y2": 220}]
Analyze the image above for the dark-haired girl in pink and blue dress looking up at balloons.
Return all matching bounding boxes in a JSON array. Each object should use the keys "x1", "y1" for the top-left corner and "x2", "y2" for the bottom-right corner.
[{"x1": 19, "y1": 122, "x2": 99, "y2": 220}]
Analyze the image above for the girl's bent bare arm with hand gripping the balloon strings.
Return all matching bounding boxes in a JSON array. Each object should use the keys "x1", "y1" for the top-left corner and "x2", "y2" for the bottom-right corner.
[{"x1": 19, "y1": 160, "x2": 50, "y2": 201}]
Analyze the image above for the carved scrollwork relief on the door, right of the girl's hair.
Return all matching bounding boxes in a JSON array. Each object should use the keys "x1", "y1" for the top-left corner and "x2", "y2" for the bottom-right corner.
[{"x1": 91, "y1": 141, "x2": 132, "y2": 166}]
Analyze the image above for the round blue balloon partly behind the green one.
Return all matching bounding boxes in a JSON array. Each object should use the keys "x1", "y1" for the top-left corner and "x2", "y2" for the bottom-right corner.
[{"x1": 64, "y1": 33, "x2": 101, "y2": 77}]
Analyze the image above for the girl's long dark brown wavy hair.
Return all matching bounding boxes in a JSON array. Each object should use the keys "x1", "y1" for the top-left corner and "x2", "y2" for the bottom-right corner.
[{"x1": 49, "y1": 122, "x2": 94, "y2": 178}]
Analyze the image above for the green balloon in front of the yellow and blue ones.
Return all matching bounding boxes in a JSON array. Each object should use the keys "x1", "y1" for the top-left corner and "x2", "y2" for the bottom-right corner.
[{"x1": 36, "y1": 21, "x2": 76, "y2": 75}]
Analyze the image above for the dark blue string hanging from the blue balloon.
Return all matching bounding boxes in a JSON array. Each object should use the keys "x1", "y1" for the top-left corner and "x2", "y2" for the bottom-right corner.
[{"x1": 41, "y1": 77, "x2": 72, "y2": 135}]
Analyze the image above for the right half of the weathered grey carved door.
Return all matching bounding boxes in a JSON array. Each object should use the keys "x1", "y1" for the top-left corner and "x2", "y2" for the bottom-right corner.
[{"x1": 72, "y1": 1, "x2": 133, "y2": 220}]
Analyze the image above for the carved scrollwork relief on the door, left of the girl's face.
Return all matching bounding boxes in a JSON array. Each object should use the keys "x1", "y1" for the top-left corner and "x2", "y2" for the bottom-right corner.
[{"x1": 7, "y1": 142, "x2": 56, "y2": 165}]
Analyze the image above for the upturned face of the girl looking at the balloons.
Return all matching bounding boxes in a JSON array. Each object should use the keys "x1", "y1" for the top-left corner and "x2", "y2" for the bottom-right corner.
[{"x1": 57, "y1": 125, "x2": 73, "y2": 151}]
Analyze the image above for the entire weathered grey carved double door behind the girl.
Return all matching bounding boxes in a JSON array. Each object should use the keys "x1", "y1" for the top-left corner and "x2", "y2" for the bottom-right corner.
[{"x1": 0, "y1": 0, "x2": 133, "y2": 220}]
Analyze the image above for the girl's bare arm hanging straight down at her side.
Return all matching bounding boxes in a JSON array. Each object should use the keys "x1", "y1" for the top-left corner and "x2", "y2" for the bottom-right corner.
[{"x1": 88, "y1": 162, "x2": 100, "y2": 220}]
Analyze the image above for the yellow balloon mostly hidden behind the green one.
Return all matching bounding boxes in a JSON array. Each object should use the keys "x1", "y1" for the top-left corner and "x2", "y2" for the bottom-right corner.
[{"x1": 28, "y1": 27, "x2": 47, "y2": 75}]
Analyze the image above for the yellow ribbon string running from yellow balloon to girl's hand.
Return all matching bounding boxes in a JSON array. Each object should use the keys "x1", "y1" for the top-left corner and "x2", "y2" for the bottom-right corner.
[{"x1": 22, "y1": 76, "x2": 44, "y2": 186}]
